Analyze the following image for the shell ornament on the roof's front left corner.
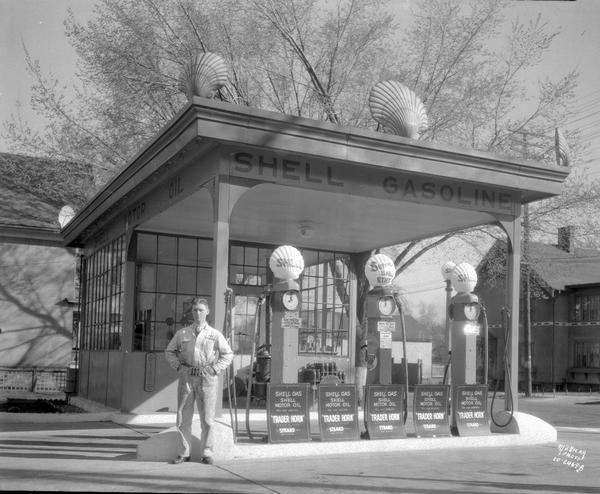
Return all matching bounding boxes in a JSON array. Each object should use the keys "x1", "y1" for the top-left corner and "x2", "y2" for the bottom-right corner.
[{"x1": 181, "y1": 52, "x2": 227, "y2": 99}]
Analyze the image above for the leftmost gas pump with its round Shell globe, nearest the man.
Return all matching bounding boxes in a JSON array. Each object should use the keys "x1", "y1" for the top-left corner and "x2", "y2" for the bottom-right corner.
[{"x1": 269, "y1": 245, "x2": 304, "y2": 384}]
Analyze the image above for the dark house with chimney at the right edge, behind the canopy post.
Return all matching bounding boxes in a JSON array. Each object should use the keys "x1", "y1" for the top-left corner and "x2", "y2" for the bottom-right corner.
[{"x1": 475, "y1": 227, "x2": 600, "y2": 390}]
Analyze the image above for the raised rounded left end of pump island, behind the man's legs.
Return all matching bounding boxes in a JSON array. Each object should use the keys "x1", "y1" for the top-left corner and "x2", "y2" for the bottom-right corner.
[{"x1": 137, "y1": 419, "x2": 239, "y2": 462}]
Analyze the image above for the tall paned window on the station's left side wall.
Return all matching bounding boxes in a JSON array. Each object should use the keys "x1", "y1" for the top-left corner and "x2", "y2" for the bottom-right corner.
[{"x1": 80, "y1": 236, "x2": 125, "y2": 351}]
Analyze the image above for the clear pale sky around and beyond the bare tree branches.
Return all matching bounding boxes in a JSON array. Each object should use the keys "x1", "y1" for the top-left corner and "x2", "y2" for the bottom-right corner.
[{"x1": 0, "y1": 0, "x2": 600, "y2": 318}]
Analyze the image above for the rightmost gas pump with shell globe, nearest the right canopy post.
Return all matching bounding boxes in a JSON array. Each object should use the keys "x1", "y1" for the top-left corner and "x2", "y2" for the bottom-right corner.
[{"x1": 448, "y1": 262, "x2": 481, "y2": 385}]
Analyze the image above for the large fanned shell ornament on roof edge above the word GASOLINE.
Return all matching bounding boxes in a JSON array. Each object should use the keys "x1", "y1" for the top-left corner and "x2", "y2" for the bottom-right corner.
[{"x1": 369, "y1": 81, "x2": 427, "y2": 139}]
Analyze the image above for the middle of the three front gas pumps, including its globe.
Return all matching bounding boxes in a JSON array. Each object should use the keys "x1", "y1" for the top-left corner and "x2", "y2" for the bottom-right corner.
[{"x1": 365, "y1": 254, "x2": 397, "y2": 384}]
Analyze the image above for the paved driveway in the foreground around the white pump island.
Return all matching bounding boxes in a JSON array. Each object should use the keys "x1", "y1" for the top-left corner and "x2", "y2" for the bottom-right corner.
[{"x1": 0, "y1": 393, "x2": 600, "y2": 494}]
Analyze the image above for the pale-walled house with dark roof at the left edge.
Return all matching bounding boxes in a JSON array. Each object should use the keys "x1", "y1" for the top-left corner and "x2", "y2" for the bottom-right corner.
[{"x1": 0, "y1": 153, "x2": 78, "y2": 391}]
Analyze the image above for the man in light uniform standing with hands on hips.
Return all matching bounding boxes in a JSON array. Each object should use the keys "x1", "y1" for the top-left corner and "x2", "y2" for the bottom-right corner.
[{"x1": 165, "y1": 297, "x2": 233, "y2": 465}]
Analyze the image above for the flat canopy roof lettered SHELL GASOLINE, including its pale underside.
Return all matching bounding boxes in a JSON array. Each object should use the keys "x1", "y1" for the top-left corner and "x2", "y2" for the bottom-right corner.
[{"x1": 63, "y1": 97, "x2": 569, "y2": 252}]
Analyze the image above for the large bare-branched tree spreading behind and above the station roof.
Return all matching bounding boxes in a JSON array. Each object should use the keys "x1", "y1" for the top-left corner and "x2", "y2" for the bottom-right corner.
[{"x1": 5, "y1": 0, "x2": 594, "y2": 378}]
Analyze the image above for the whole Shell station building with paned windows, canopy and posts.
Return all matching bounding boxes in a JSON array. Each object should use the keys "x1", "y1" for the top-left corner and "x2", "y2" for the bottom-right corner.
[{"x1": 61, "y1": 97, "x2": 569, "y2": 413}]
